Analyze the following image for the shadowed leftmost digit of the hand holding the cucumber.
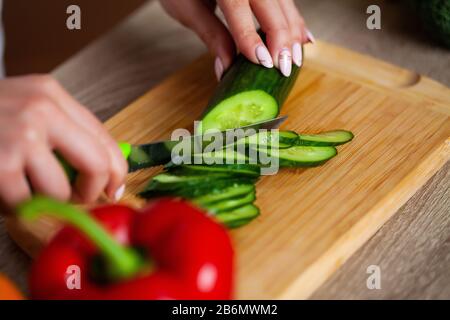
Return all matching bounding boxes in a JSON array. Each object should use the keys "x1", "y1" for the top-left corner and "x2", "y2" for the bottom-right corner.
[{"x1": 166, "y1": 0, "x2": 236, "y2": 80}]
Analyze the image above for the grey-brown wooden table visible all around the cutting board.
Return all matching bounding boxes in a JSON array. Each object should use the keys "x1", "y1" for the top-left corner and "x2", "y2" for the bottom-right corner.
[{"x1": 0, "y1": 0, "x2": 450, "y2": 299}]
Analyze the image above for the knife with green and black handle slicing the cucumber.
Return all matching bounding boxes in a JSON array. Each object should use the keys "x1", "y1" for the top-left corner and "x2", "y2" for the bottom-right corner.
[{"x1": 57, "y1": 116, "x2": 287, "y2": 182}]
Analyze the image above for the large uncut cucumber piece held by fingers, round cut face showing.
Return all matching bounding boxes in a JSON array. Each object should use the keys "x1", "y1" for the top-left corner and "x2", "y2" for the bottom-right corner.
[{"x1": 197, "y1": 45, "x2": 300, "y2": 134}]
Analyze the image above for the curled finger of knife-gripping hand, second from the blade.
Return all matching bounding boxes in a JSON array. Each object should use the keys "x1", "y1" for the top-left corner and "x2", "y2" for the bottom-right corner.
[{"x1": 49, "y1": 111, "x2": 111, "y2": 203}]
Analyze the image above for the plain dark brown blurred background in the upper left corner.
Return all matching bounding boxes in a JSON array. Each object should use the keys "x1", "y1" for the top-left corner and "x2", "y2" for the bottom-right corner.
[{"x1": 3, "y1": 0, "x2": 146, "y2": 75}]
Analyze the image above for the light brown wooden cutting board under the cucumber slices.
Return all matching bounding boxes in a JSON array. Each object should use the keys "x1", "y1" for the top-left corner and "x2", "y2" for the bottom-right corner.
[{"x1": 5, "y1": 42, "x2": 450, "y2": 299}]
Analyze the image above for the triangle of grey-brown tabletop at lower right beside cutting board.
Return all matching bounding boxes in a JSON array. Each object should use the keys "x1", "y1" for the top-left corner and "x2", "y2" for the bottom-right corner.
[{"x1": 312, "y1": 163, "x2": 450, "y2": 300}]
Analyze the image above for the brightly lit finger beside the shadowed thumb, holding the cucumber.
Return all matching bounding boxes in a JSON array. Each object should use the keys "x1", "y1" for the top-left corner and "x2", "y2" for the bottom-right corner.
[{"x1": 217, "y1": 0, "x2": 273, "y2": 68}]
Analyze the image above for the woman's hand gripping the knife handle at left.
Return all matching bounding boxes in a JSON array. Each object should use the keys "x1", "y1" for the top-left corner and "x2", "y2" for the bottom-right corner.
[{"x1": 0, "y1": 75, "x2": 127, "y2": 208}]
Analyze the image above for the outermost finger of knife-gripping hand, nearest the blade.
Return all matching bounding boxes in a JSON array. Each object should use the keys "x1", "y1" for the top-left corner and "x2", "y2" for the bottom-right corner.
[{"x1": 24, "y1": 76, "x2": 128, "y2": 198}]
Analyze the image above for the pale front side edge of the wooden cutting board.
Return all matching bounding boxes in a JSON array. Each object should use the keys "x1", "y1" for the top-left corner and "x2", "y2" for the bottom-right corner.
[{"x1": 277, "y1": 137, "x2": 450, "y2": 300}]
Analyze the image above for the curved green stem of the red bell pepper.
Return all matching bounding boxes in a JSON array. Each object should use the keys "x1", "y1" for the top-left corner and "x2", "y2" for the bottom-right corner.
[{"x1": 17, "y1": 196, "x2": 144, "y2": 279}]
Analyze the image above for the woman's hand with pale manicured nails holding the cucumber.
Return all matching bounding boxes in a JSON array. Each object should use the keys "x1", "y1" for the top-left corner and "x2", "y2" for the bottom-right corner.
[{"x1": 161, "y1": 0, "x2": 314, "y2": 79}]
